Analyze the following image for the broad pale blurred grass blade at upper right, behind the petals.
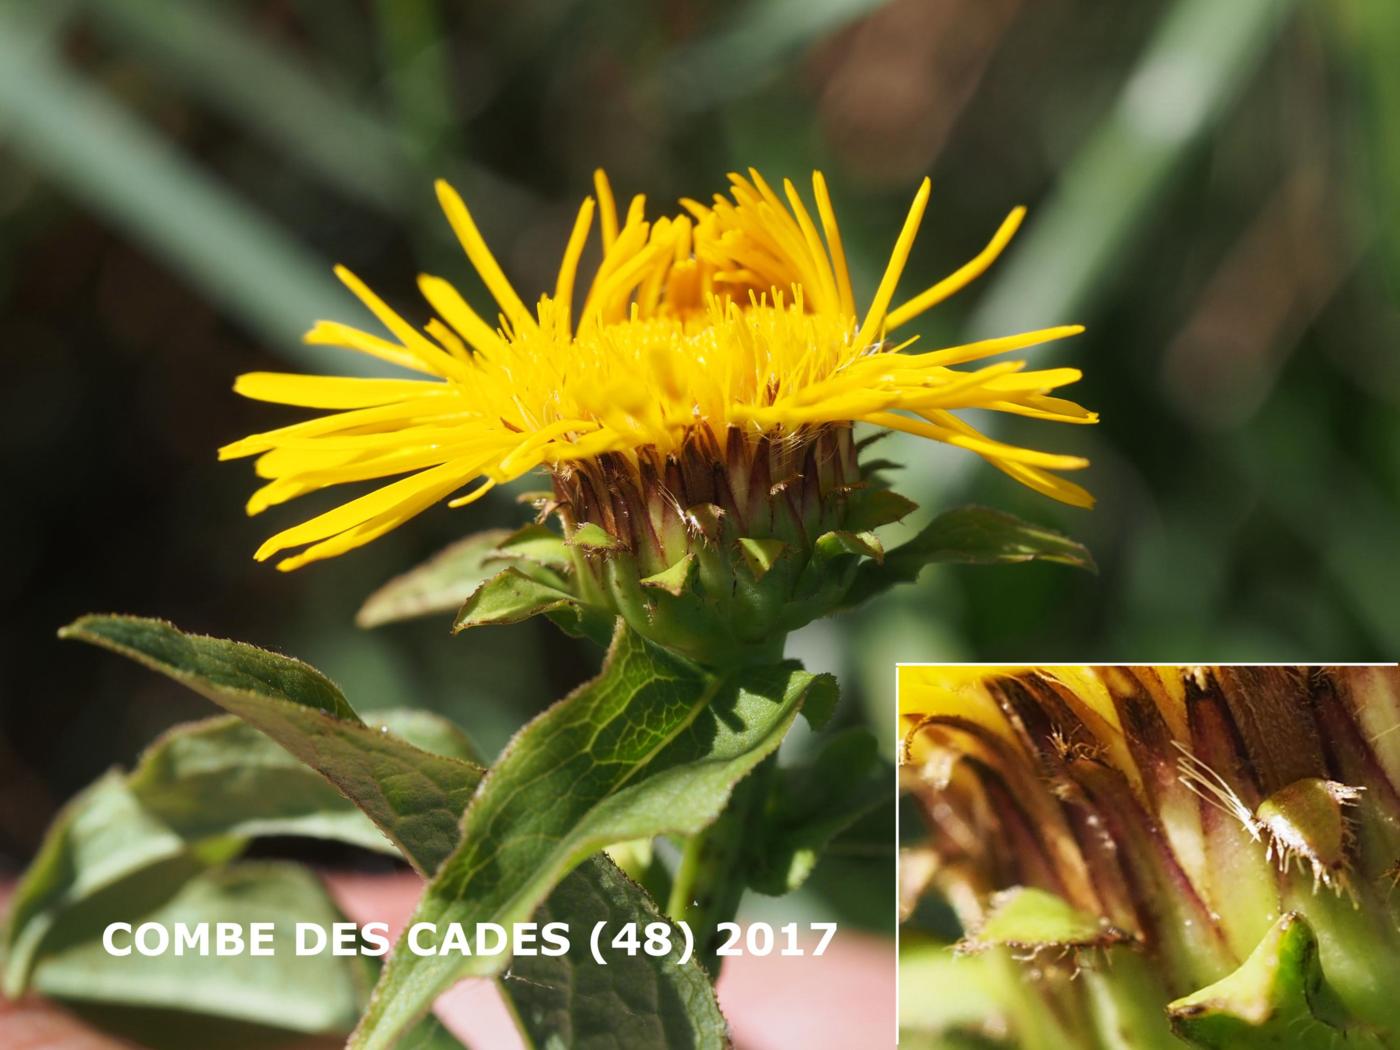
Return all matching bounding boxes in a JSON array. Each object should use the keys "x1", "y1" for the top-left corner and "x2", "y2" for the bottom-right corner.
[{"x1": 970, "y1": 0, "x2": 1295, "y2": 339}]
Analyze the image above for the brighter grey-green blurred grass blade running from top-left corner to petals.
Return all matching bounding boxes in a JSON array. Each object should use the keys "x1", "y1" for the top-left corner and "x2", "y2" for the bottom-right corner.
[{"x1": 0, "y1": 4, "x2": 366, "y2": 374}]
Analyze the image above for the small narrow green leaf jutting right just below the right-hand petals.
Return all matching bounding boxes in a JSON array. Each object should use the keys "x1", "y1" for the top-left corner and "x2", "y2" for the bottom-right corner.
[{"x1": 846, "y1": 507, "x2": 1098, "y2": 606}]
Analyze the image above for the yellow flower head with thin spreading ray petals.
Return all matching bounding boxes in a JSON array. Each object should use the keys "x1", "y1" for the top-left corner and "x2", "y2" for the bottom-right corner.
[{"x1": 220, "y1": 171, "x2": 1096, "y2": 570}]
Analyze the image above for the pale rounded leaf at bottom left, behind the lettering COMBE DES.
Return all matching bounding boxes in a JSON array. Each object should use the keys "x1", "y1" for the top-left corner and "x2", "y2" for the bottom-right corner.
[{"x1": 34, "y1": 862, "x2": 371, "y2": 1035}]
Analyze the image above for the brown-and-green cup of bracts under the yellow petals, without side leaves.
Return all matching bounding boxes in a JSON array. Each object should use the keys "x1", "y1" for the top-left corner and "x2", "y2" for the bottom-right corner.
[{"x1": 547, "y1": 426, "x2": 911, "y2": 664}]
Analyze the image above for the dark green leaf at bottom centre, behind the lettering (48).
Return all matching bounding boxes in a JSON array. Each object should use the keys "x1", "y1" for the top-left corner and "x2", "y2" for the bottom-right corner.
[{"x1": 504, "y1": 862, "x2": 728, "y2": 1050}]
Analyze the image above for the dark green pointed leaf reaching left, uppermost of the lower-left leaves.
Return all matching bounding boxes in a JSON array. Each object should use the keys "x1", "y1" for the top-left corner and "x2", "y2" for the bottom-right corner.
[{"x1": 60, "y1": 616, "x2": 480, "y2": 872}]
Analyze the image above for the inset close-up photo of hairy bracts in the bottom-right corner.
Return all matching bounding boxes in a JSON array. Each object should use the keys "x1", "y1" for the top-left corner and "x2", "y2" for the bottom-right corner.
[{"x1": 899, "y1": 664, "x2": 1400, "y2": 1050}]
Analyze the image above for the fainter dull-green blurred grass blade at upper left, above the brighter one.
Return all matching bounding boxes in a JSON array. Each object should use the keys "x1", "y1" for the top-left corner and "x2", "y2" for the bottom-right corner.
[{"x1": 85, "y1": 0, "x2": 411, "y2": 211}]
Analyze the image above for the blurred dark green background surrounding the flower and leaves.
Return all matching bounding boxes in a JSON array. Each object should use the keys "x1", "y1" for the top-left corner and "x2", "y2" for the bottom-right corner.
[{"x1": 0, "y1": 0, "x2": 1400, "y2": 924}]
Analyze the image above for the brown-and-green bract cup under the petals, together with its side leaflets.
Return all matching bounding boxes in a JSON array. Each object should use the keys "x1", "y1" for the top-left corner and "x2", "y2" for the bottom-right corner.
[{"x1": 420, "y1": 427, "x2": 1093, "y2": 669}]
